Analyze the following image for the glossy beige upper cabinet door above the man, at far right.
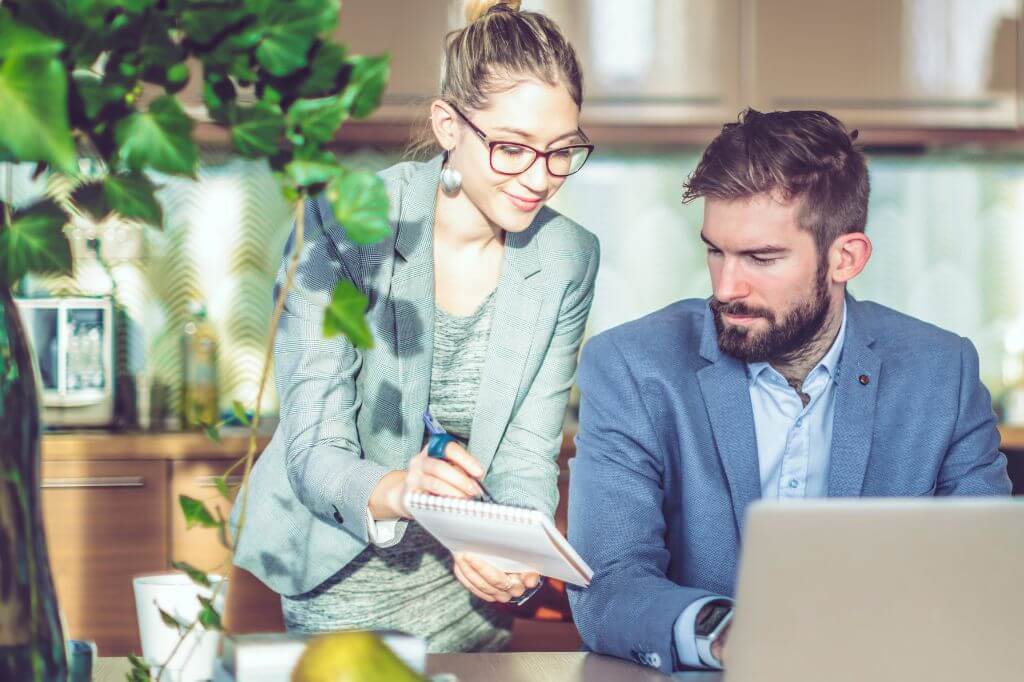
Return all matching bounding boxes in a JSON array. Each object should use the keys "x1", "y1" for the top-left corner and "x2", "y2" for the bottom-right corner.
[{"x1": 744, "y1": 0, "x2": 1020, "y2": 128}]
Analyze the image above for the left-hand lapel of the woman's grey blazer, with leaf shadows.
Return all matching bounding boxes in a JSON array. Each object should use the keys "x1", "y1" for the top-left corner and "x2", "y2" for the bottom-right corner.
[{"x1": 390, "y1": 157, "x2": 440, "y2": 450}]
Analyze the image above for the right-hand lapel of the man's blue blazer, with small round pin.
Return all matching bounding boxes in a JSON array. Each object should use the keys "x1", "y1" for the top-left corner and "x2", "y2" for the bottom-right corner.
[{"x1": 828, "y1": 296, "x2": 882, "y2": 498}]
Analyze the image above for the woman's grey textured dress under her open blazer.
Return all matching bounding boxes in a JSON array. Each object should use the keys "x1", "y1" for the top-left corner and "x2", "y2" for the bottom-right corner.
[{"x1": 282, "y1": 293, "x2": 512, "y2": 652}]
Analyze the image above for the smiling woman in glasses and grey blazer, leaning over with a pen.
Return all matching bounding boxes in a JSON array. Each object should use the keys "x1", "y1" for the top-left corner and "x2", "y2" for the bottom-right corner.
[{"x1": 234, "y1": 2, "x2": 598, "y2": 651}]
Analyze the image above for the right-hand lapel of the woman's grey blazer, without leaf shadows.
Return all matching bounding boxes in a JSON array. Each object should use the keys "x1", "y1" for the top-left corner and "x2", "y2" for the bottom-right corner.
[{"x1": 469, "y1": 222, "x2": 544, "y2": 470}]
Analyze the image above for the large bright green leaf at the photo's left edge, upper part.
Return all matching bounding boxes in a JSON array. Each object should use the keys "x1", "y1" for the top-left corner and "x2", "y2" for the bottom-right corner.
[{"x1": 0, "y1": 56, "x2": 76, "y2": 173}]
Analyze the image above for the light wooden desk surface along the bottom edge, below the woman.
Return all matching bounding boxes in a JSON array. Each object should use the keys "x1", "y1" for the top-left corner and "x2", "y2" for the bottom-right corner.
[{"x1": 92, "y1": 651, "x2": 722, "y2": 682}]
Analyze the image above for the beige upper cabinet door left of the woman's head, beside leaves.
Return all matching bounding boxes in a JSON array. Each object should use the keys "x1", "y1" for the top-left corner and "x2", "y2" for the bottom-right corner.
[{"x1": 335, "y1": 0, "x2": 452, "y2": 121}]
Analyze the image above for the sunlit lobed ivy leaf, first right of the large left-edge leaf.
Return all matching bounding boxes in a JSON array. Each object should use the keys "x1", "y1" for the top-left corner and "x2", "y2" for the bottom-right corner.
[{"x1": 115, "y1": 95, "x2": 199, "y2": 176}]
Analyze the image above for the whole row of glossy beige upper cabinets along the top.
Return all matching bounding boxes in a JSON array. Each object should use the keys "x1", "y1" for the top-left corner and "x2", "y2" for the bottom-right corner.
[{"x1": 329, "y1": 0, "x2": 1022, "y2": 131}]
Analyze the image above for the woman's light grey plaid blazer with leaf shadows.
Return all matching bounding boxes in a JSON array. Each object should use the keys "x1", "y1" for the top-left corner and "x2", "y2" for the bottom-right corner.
[{"x1": 231, "y1": 157, "x2": 600, "y2": 595}]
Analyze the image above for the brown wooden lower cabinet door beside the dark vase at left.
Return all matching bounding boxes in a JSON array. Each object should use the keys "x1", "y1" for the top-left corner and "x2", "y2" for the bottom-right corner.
[{"x1": 42, "y1": 462, "x2": 168, "y2": 656}]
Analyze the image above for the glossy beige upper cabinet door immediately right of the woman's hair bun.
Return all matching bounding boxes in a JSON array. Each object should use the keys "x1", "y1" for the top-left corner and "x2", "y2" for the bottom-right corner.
[{"x1": 522, "y1": 0, "x2": 739, "y2": 125}]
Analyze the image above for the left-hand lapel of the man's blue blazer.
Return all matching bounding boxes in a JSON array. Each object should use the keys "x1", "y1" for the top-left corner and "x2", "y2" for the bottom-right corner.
[{"x1": 697, "y1": 310, "x2": 761, "y2": 534}]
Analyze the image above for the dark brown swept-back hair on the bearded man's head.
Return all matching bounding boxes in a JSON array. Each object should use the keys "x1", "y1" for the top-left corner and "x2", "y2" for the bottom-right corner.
[{"x1": 683, "y1": 109, "x2": 869, "y2": 259}]
